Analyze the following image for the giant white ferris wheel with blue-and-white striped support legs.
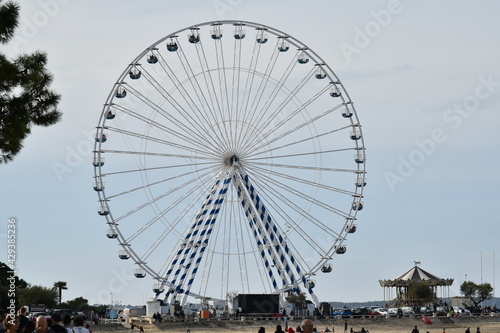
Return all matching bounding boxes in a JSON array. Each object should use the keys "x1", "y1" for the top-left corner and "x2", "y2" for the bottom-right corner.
[{"x1": 93, "y1": 21, "x2": 366, "y2": 304}]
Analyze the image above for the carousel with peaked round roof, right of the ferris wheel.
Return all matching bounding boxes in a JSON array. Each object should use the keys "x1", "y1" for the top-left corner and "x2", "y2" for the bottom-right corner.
[{"x1": 379, "y1": 261, "x2": 453, "y2": 305}]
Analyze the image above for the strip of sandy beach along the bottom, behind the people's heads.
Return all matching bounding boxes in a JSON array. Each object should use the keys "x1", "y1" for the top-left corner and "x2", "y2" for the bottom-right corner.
[{"x1": 91, "y1": 316, "x2": 500, "y2": 333}]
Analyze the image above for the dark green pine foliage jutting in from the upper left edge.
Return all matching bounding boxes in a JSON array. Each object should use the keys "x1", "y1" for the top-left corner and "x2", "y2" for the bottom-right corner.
[{"x1": 0, "y1": 0, "x2": 61, "y2": 163}]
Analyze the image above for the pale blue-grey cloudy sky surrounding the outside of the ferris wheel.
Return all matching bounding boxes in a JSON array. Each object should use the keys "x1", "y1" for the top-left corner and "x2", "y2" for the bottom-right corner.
[{"x1": 0, "y1": 0, "x2": 500, "y2": 305}]
